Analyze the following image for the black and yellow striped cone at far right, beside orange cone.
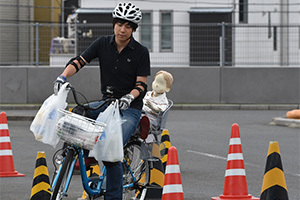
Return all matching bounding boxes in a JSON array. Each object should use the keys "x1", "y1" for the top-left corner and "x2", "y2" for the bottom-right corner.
[{"x1": 260, "y1": 141, "x2": 289, "y2": 200}]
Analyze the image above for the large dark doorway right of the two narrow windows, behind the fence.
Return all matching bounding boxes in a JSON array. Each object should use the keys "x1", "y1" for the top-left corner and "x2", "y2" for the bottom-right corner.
[{"x1": 189, "y1": 8, "x2": 233, "y2": 66}]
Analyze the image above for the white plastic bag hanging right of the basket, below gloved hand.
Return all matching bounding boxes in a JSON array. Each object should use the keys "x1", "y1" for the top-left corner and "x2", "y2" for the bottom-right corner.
[{"x1": 92, "y1": 100, "x2": 124, "y2": 162}]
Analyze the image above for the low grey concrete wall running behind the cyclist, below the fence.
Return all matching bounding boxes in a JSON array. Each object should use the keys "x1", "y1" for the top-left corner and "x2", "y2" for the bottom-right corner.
[{"x1": 0, "y1": 66, "x2": 300, "y2": 104}]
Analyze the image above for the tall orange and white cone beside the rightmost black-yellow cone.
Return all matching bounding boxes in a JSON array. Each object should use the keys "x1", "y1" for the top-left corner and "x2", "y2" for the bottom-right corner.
[{"x1": 211, "y1": 123, "x2": 259, "y2": 200}]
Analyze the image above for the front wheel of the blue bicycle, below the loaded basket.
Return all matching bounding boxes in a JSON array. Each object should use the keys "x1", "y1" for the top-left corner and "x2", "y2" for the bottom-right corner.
[{"x1": 51, "y1": 149, "x2": 75, "y2": 200}]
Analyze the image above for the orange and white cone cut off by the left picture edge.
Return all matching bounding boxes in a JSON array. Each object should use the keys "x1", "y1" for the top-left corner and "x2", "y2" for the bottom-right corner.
[{"x1": 0, "y1": 112, "x2": 25, "y2": 177}]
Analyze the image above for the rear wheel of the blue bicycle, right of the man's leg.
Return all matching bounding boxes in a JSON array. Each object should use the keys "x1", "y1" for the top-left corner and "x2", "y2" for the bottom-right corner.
[{"x1": 123, "y1": 141, "x2": 146, "y2": 200}]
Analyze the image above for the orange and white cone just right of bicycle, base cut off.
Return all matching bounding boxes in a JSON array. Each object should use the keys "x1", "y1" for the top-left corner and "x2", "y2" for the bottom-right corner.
[{"x1": 162, "y1": 146, "x2": 184, "y2": 200}]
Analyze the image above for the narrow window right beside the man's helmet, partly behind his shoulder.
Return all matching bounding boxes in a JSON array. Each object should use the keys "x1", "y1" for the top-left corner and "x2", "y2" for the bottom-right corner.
[{"x1": 140, "y1": 12, "x2": 152, "y2": 51}]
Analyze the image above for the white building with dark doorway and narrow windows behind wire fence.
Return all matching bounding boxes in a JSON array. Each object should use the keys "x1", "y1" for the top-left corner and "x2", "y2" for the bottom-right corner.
[{"x1": 76, "y1": 0, "x2": 300, "y2": 67}]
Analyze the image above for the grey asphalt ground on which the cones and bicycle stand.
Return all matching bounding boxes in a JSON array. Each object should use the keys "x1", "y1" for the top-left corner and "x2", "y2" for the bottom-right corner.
[{"x1": 0, "y1": 105, "x2": 300, "y2": 200}]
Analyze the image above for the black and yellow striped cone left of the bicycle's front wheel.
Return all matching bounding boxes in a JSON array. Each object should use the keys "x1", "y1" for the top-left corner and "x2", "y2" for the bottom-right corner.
[{"x1": 30, "y1": 151, "x2": 51, "y2": 200}]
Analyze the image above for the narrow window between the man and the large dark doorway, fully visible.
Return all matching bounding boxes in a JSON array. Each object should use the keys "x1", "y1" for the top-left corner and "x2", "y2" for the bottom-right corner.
[{"x1": 160, "y1": 11, "x2": 173, "y2": 51}]
